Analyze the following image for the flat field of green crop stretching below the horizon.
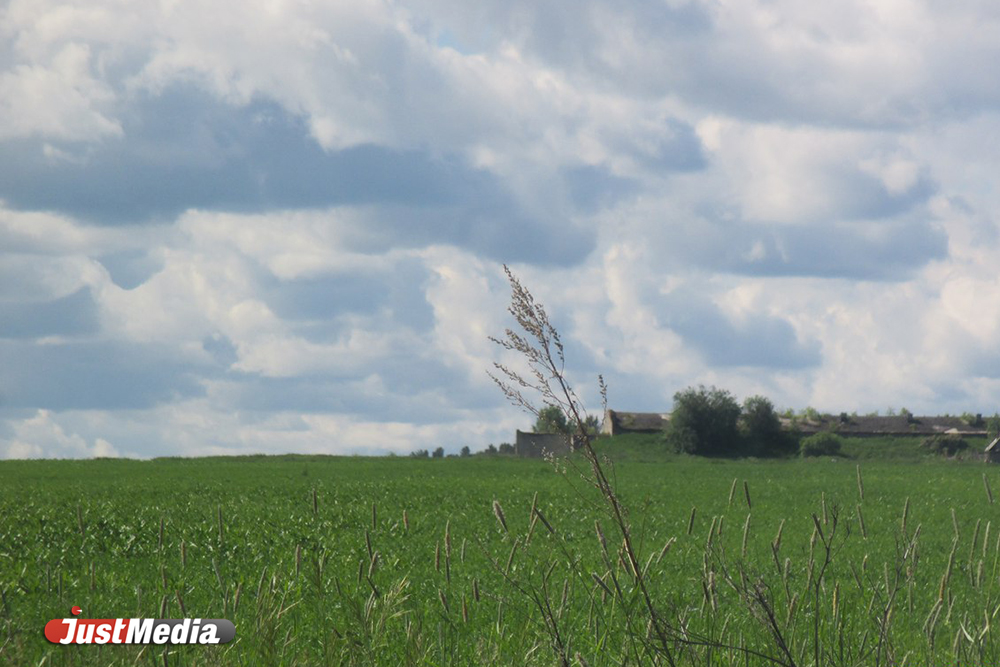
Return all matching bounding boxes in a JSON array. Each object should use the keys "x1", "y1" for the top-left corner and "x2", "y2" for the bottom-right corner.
[{"x1": 0, "y1": 456, "x2": 1000, "y2": 667}]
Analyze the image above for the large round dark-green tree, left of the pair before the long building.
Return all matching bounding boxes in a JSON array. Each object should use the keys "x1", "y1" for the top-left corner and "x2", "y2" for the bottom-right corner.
[{"x1": 667, "y1": 385, "x2": 741, "y2": 456}]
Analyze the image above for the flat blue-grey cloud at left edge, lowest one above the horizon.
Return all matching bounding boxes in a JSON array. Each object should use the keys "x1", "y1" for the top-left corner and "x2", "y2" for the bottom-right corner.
[{"x1": 0, "y1": 341, "x2": 211, "y2": 410}]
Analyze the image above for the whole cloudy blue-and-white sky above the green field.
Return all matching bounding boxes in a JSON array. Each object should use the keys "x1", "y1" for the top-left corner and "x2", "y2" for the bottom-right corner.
[{"x1": 0, "y1": 0, "x2": 1000, "y2": 458}]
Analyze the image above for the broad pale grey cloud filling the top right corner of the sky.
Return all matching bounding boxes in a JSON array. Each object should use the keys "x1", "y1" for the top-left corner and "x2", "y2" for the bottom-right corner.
[{"x1": 425, "y1": 2, "x2": 1000, "y2": 128}]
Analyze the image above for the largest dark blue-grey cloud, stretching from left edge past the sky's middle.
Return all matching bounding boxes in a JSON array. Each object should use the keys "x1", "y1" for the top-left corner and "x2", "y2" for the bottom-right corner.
[{"x1": 0, "y1": 88, "x2": 593, "y2": 266}]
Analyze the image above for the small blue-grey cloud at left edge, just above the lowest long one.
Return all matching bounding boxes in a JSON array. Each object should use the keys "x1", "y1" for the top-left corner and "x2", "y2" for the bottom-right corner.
[{"x1": 0, "y1": 287, "x2": 100, "y2": 338}]
